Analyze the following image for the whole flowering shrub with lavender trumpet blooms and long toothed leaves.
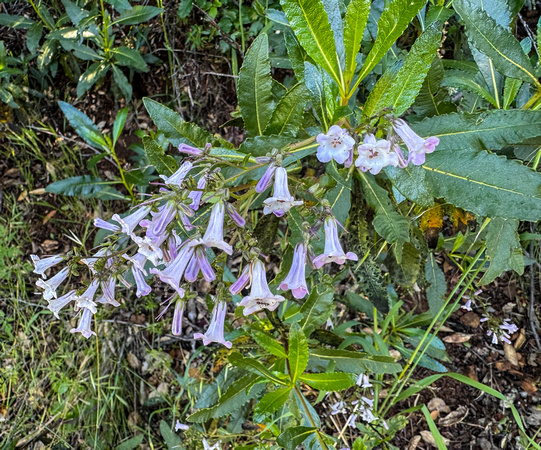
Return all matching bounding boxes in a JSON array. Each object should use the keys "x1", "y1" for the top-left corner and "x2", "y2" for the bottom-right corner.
[{"x1": 34, "y1": 0, "x2": 541, "y2": 449}]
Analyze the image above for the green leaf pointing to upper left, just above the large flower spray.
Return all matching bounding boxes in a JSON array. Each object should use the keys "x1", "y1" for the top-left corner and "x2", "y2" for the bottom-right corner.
[{"x1": 143, "y1": 97, "x2": 215, "y2": 148}]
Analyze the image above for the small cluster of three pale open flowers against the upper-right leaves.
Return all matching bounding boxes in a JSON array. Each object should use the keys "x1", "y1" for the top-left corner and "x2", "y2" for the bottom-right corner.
[{"x1": 316, "y1": 119, "x2": 440, "y2": 175}]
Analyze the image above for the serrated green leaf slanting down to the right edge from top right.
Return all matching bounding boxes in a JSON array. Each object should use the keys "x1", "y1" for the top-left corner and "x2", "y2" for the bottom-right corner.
[{"x1": 453, "y1": 0, "x2": 541, "y2": 88}]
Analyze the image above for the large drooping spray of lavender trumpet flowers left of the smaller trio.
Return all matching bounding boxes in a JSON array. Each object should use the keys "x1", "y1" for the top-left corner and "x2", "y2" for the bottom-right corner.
[{"x1": 32, "y1": 141, "x2": 358, "y2": 348}]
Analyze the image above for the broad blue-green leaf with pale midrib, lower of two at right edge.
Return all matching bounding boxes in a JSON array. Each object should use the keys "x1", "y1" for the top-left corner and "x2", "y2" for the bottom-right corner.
[{"x1": 423, "y1": 150, "x2": 541, "y2": 221}]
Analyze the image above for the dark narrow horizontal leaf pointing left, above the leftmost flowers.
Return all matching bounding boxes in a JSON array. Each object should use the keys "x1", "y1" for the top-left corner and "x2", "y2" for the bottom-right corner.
[{"x1": 45, "y1": 175, "x2": 126, "y2": 200}]
